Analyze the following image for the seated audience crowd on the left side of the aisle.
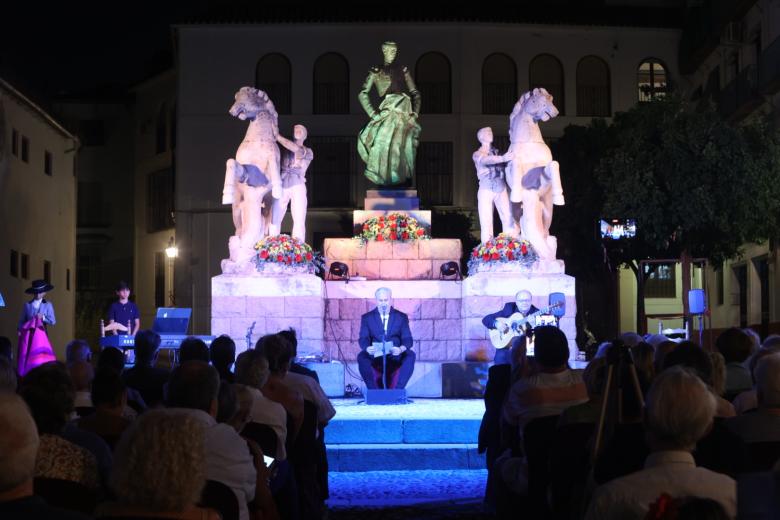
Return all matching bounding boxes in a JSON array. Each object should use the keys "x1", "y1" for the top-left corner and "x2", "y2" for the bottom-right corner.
[{"x1": 0, "y1": 330, "x2": 335, "y2": 520}]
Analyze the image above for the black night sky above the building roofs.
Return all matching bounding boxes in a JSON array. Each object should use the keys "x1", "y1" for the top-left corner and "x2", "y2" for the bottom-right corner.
[{"x1": 0, "y1": 0, "x2": 682, "y2": 106}]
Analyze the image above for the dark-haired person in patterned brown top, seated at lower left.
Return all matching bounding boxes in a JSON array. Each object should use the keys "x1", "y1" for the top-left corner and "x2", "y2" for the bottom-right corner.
[{"x1": 19, "y1": 362, "x2": 99, "y2": 490}]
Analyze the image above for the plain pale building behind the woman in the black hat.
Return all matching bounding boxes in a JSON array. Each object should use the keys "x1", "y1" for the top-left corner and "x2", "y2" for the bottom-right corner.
[{"x1": 0, "y1": 79, "x2": 78, "y2": 357}]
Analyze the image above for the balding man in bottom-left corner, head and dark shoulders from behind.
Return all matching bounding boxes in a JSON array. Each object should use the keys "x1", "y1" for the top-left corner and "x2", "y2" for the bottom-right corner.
[{"x1": 0, "y1": 391, "x2": 88, "y2": 520}]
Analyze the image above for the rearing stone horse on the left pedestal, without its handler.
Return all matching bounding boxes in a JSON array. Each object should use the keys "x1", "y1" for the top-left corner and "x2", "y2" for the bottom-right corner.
[{"x1": 222, "y1": 87, "x2": 282, "y2": 272}]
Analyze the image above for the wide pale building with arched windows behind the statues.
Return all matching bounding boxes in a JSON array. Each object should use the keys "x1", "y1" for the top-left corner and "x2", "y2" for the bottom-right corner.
[{"x1": 163, "y1": 22, "x2": 680, "y2": 333}]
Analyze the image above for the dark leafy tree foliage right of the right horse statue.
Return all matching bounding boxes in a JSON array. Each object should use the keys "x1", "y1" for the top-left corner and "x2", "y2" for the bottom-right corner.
[{"x1": 595, "y1": 96, "x2": 780, "y2": 263}]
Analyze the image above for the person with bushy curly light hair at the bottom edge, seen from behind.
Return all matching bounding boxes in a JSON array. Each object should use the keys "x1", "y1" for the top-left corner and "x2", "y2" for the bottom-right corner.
[{"x1": 98, "y1": 410, "x2": 221, "y2": 520}]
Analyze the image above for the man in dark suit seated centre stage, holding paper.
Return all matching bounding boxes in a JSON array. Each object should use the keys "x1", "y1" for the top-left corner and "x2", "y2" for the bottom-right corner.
[{"x1": 357, "y1": 287, "x2": 415, "y2": 389}]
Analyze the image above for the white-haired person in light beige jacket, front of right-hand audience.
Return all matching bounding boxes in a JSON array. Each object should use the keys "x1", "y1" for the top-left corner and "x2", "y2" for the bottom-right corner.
[{"x1": 586, "y1": 366, "x2": 737, "y2": 520}]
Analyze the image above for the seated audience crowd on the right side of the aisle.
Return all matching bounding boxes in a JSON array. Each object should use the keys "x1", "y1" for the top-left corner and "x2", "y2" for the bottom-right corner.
[{"x1": 479, "y1": 327, "x2": 780, "y2": 519}]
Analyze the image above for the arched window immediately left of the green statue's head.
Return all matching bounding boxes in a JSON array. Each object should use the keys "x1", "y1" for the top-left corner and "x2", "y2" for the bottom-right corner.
[{"x1": 313, "y1": 52, "x2": 349, "y2": 114}]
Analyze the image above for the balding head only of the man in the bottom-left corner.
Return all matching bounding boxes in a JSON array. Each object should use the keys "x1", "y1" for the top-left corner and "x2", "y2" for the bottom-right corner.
[{"x1": 0, "y1": 392, "x2": 39, "y2": 493}]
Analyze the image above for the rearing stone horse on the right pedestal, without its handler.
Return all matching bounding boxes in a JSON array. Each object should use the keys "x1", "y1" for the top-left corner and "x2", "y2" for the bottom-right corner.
[{"x1": 506, "y1": 88, "x2": 564, "y2": 260}]
